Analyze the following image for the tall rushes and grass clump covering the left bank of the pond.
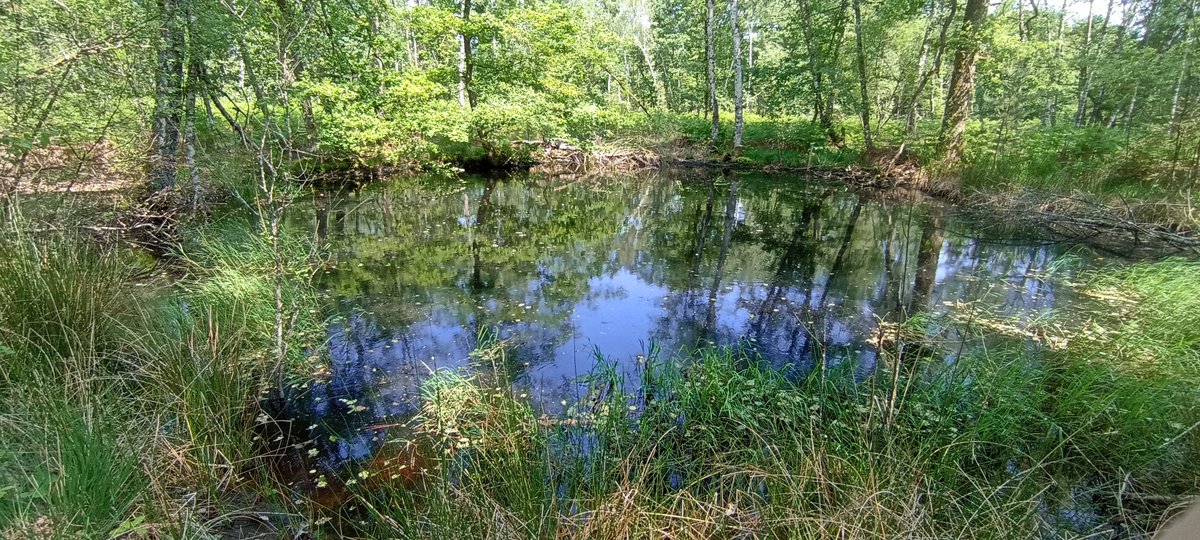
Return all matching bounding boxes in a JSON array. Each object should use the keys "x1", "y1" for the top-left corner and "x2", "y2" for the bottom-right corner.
[{"x1": 0, "y1": 222, "x2": 328, "y2": 538}]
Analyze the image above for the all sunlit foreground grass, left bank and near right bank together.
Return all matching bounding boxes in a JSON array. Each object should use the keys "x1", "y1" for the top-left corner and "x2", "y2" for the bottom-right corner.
[{"x1": 0, "y1": 220, "x2": 1200, "y2": 539}]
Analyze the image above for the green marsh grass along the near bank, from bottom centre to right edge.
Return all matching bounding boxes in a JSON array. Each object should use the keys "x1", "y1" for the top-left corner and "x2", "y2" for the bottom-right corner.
[{"x1": 321, "y1": 276, "x2": 1200, "y2": 538}]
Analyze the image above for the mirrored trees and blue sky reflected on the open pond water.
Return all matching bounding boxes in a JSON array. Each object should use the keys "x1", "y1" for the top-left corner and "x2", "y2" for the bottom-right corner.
[{"x1": 288, "y1": 176, "x2": 1070, "y2": 412}]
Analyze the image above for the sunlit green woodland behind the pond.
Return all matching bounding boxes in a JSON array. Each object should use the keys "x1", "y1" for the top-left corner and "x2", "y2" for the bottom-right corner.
[{"x1": 0, "y1": 0, "x2": 1200, "y2": 202}]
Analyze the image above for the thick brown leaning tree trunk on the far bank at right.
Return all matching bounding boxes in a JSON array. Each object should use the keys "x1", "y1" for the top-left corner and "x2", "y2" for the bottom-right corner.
[{"x1": 938, "y1": 0, "x2": 988, "y2": 177}]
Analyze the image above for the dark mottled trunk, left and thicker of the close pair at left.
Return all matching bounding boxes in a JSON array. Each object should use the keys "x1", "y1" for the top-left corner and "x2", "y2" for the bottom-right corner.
[{"x1": 150, "y1": 0, "x2": 184, "y2": 191}]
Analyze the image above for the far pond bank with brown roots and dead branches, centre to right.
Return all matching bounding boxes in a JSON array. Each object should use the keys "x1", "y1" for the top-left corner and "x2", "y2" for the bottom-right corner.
[{"x1": 521, "y1": 139, "x2": 1200, "y2": 258}]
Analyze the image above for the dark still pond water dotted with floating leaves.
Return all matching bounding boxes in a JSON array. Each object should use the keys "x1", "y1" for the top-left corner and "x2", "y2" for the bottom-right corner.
[{"x1": 289, "y1": 170, "x2": 1080, "y2": 464}]
